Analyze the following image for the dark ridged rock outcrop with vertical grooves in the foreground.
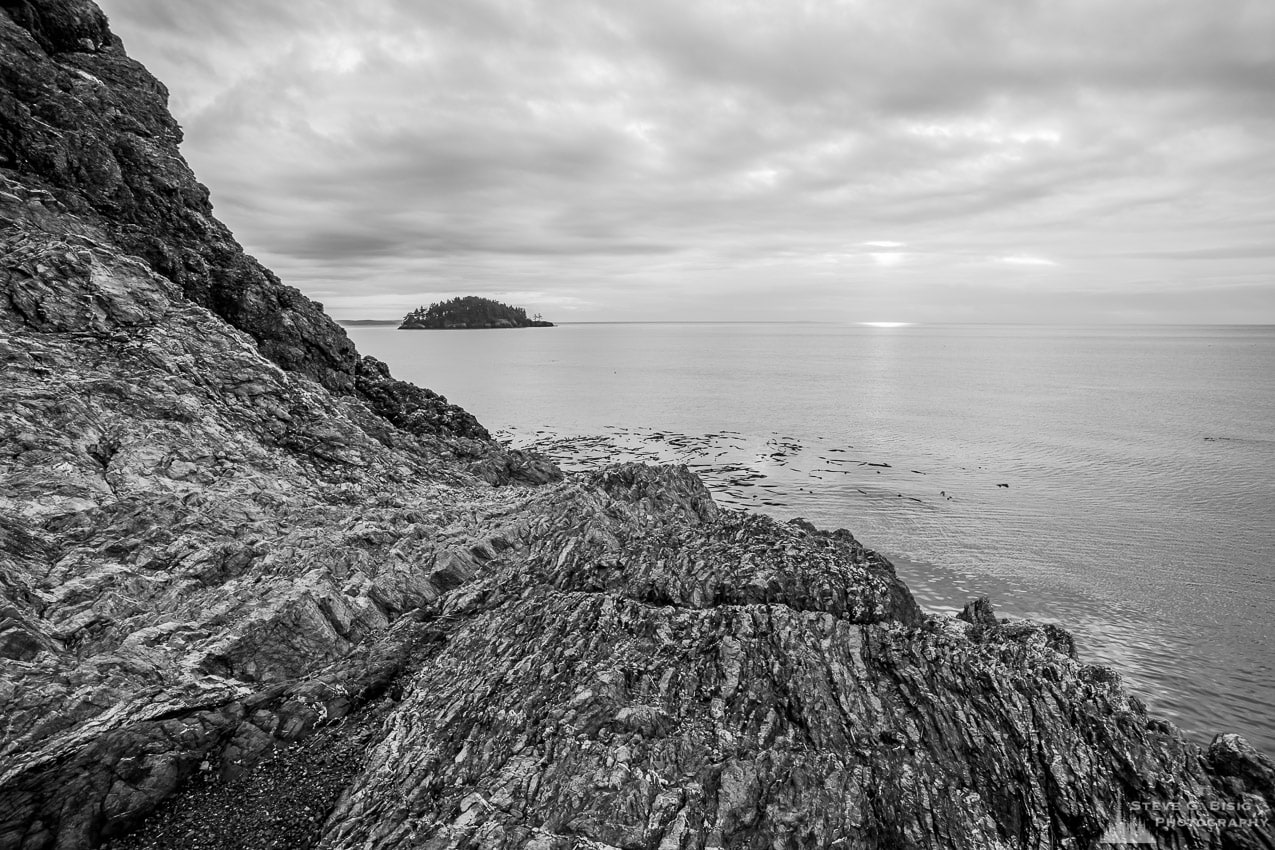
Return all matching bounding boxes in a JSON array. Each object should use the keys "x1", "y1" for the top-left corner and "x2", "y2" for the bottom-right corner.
[{"x1": 321, "y1": 484, "x2": 1270, "y2": 847}]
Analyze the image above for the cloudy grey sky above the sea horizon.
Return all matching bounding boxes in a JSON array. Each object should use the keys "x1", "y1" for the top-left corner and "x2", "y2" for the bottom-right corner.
[{"x1": 99, "y1": 0, "x2": 1275, "y2": 324}]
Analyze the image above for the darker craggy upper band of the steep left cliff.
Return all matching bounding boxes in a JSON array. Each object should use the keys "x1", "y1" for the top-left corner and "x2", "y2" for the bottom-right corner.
[{"x1": 0, "y1": 0, "x2": 555, "y2": 480}]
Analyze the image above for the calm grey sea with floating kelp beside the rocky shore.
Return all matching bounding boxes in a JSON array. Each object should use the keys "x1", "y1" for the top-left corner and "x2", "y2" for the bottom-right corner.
[{"x1": 348, "y1": 324, "x2": 1275, "y2": 756}]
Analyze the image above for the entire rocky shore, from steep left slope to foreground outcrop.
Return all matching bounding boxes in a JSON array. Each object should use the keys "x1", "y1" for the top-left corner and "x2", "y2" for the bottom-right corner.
[{"x1": 0, "y1": 0, "x2": 1275, "y2": 850}]
